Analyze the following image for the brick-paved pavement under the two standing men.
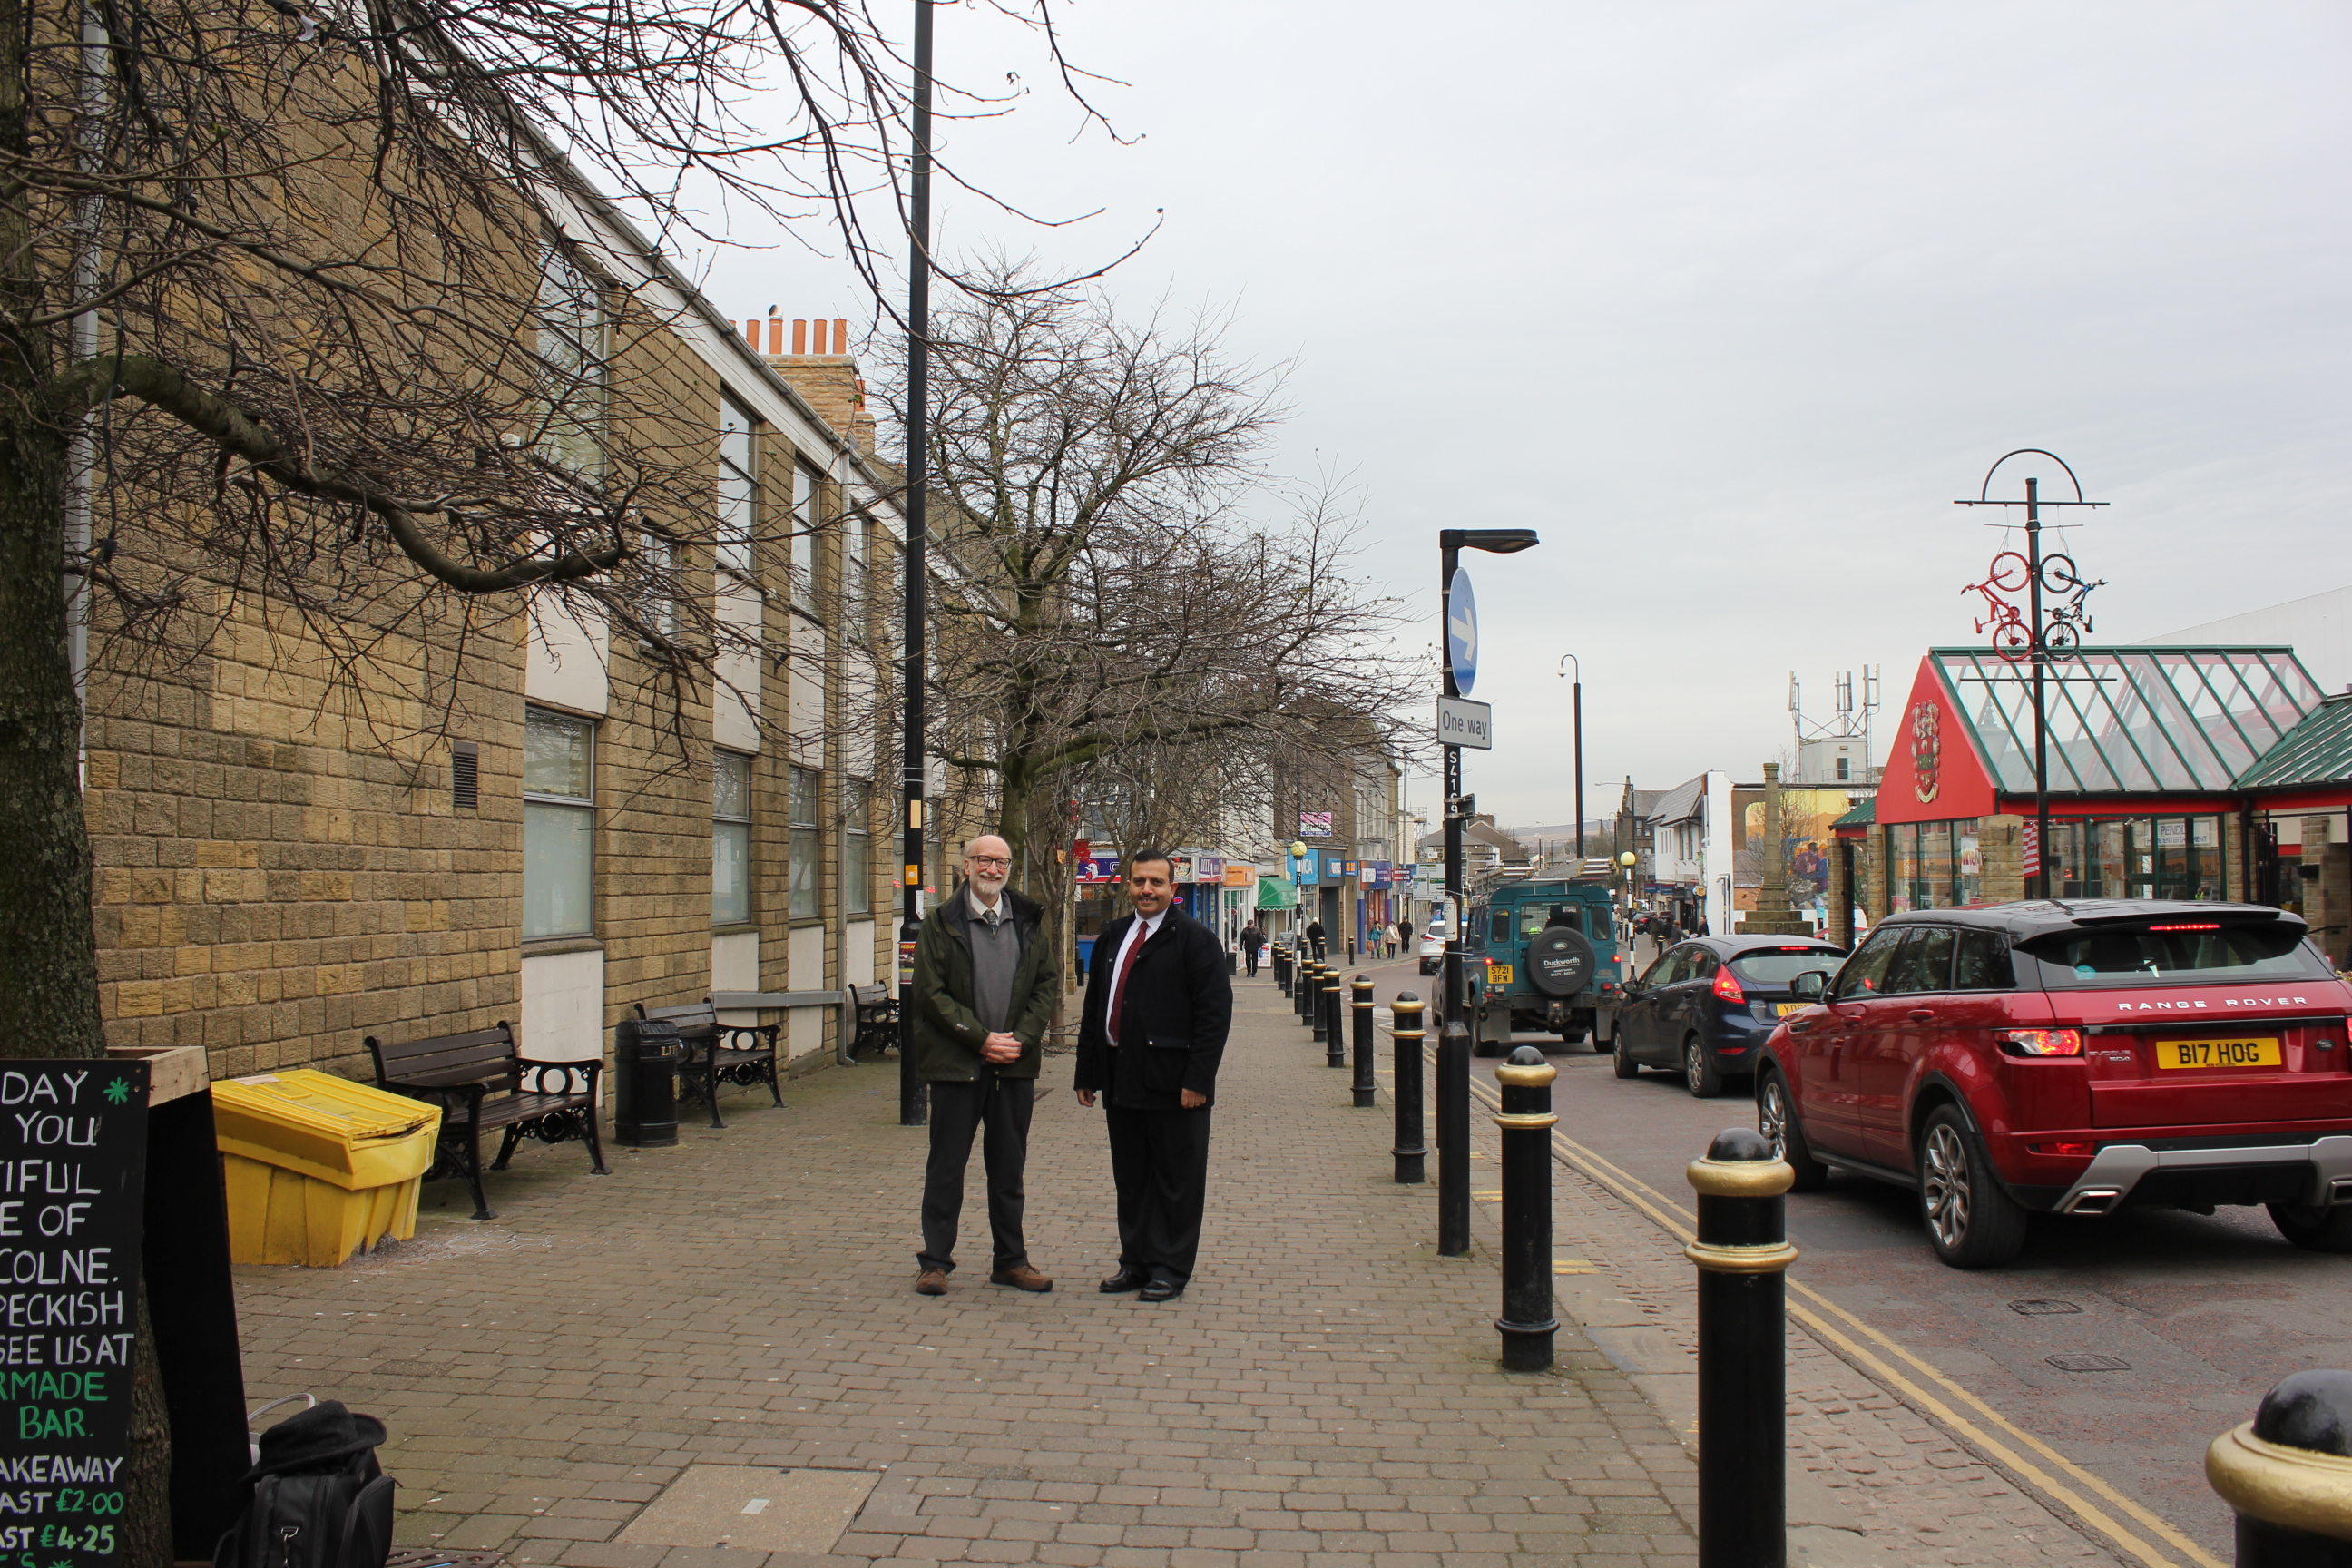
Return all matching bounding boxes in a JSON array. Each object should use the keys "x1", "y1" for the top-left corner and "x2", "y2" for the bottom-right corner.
[{"x1": 238, "y1": 983, "x2": 1693, "y2": 1568}]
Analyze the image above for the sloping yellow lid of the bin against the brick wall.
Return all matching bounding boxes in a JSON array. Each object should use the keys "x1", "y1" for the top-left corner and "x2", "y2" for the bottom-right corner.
[{"x1": 211, "y1": 1067, "x2": 440, "y2": 1190}]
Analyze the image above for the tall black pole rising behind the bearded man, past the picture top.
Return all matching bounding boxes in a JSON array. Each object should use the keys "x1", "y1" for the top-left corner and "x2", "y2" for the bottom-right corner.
[{"x1": 898, "y1": 0, "x2": 931, "y2": 1126}]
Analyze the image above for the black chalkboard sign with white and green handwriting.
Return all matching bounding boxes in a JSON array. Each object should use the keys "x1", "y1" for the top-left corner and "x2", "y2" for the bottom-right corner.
[{"x1": 0, "y1": 1058, "x2": 148, "y2": 1568}]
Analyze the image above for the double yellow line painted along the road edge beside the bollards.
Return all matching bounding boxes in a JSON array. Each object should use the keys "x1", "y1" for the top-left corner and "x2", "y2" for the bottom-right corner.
[{"x1": 1433, "y1": 1058, "x2": 2228, "y2": 1568}]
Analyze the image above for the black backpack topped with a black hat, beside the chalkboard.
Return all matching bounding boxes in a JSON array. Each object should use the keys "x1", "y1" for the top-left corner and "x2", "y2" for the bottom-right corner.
[{"x1": 211, "y1": 1398, "x2": 393, "y2": 1568}]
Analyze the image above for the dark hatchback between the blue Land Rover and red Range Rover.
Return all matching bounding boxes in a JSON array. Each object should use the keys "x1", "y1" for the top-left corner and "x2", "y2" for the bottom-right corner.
[{"x1": 1609, "y1": 936, "x2": 1847, "y2": 1100}]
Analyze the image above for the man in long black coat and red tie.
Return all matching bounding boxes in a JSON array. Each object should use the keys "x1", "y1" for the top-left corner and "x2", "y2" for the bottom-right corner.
[{"x1": 1077, "y1": 848, "x2": 1232, "y2": 1302}]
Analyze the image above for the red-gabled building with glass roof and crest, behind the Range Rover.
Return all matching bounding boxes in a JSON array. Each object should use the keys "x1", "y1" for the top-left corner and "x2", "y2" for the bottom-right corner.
[{"x1": 1839, "y1": 646, "x2": 2321, "y2": 916}]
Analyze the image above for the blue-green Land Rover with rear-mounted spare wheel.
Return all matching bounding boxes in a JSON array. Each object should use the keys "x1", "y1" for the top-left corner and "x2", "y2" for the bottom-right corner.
[{"x1": 1463, "y1": 860, "x2": 1625, "y2": 1055}]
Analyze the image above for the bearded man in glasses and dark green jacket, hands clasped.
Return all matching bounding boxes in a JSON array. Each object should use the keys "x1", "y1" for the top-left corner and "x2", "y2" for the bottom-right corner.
[{"x1": 915, "y1": 832, "x2": 1058, "y2": 1295}]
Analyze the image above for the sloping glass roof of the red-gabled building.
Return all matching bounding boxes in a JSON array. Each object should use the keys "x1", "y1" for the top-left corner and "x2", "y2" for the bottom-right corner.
[{"x1": 1928, "y1": 646, "x2": 2324, "y2": 795}]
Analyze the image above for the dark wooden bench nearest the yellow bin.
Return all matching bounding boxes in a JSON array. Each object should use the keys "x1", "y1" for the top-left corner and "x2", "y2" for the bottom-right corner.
[{"x1": 367, "y1": 1020, "x2": 612, "y2": 1220}]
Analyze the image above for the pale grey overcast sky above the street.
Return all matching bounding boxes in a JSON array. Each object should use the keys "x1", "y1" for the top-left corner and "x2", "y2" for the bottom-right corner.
[{"x1": 703, "y1": 0, "x2": 2352, "y2": 823}]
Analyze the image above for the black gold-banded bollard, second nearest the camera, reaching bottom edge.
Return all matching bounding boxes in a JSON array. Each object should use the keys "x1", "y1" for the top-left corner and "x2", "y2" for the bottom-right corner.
[{"x1": 1681, "y1": 1126, "x2": 1797, "y2": 1568}]
